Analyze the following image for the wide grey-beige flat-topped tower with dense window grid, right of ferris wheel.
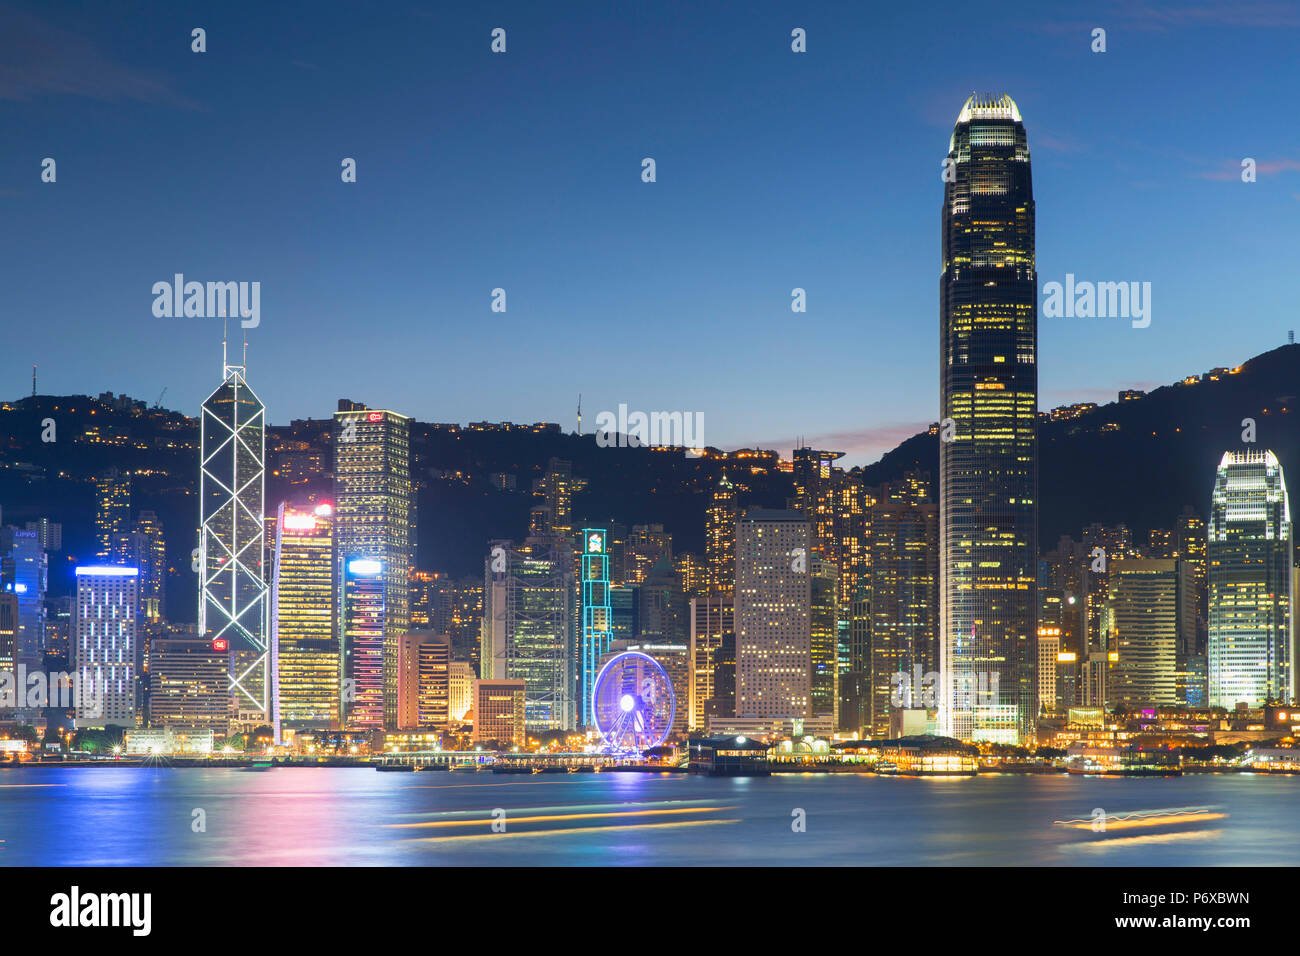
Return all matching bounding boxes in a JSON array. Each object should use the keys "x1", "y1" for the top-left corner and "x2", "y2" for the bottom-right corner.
[{"x1": 736, "y1": 509, "x2": 813, "y2": 717}]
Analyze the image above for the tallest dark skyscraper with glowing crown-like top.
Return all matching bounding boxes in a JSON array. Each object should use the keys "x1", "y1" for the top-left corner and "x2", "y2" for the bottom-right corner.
[{"x1": 939, "y1": 95, "x2": 1039, "y2": 743}]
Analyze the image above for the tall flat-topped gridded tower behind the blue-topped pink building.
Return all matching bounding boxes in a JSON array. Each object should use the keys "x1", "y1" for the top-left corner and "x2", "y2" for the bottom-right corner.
[{"x1": 334, "y1": 399, "x2": 415, "y2": 727}]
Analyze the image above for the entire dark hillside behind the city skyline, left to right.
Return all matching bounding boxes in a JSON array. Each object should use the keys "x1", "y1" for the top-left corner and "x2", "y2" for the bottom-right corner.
[{"x1": 0, "y1": 346, "x2": 1300, "y2": 620}]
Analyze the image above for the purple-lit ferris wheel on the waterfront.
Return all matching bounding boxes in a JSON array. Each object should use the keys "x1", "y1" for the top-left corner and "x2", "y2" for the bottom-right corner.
[{"x1": 592, "y1": 650, "x2": 677, "y2": 750}]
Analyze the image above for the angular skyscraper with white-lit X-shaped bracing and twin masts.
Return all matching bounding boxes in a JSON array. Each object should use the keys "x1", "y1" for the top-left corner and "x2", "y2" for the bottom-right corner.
[{"x1": 198, "y1": 339, "x2": 270, "y2": 740}]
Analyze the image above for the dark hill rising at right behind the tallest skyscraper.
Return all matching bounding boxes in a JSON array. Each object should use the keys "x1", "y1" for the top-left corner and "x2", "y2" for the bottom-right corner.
[{"x1": 863, "y1": 345, "x2": 1300, "y2": 548}]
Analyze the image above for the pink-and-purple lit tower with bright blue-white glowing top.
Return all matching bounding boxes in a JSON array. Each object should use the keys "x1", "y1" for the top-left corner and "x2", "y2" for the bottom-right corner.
[{"x1": 339, "y1": 555, "x2": 389, "y2": 730}]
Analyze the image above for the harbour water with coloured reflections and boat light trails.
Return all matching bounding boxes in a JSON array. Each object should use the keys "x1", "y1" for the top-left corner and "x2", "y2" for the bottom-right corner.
[{"x1": 0, "y1": 767, "x2": 1300, "y2": 866}]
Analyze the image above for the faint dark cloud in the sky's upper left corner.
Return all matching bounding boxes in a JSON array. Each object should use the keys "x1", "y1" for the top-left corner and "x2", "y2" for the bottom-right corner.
[{"x1": 0, "y1": 7, "x2": 199, "y2": 109}]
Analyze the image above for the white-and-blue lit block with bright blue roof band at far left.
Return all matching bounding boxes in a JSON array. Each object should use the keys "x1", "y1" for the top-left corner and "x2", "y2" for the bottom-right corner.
[{"x1": 73, "y1": 564, "x2": 139, "y2": 727}]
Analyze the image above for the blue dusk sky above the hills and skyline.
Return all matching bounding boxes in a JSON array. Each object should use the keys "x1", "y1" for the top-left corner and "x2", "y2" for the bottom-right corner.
[{"x1": 0, "y1": 1, "x2": 1300, "y2": 463}]
